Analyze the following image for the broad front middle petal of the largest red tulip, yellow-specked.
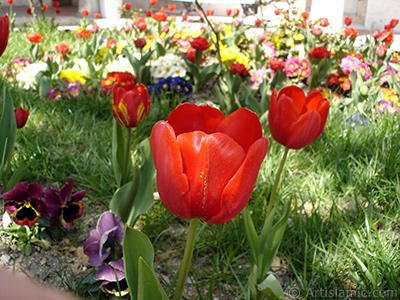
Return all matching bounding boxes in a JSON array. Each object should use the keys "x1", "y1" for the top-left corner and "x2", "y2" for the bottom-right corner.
[{"x1": 177, "y1": 131, "x2": 246, "y2": 220}]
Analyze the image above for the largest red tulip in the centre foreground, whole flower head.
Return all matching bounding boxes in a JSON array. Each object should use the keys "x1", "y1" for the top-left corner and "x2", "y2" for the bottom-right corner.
[{"x1": 150, "y1": 103, "x2": 268, "y2": 224}]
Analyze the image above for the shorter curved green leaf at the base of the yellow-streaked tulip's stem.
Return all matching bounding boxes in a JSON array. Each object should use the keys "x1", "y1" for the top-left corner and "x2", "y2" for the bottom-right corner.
[{"x1": 109, "y1": 168, "x2": 141, "y2": 223}]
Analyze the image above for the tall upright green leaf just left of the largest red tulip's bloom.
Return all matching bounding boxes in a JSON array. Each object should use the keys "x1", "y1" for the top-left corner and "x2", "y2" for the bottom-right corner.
[{"x1": 127, "y1": 138, "x2": 155, "y2": 227}]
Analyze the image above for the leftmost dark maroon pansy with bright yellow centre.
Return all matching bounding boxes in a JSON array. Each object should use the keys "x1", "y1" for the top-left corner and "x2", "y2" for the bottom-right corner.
[{"x1": 1, "y1": 182, "x2": 47, "y2": 227}]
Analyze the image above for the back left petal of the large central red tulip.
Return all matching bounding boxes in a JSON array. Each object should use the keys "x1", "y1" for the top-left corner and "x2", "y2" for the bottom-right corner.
[{"x1": 168, "y1": 103, "x2": 224, "y2": 136}]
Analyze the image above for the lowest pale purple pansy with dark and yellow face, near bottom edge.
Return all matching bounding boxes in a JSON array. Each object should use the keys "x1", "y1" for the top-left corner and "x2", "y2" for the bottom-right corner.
[{"x1": 93, "y1": 259, "x2": 129, "y2": 296}]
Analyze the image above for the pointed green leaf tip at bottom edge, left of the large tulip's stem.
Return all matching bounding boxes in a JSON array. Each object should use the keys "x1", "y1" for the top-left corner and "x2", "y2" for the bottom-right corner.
[{"x1": 137, "y1": 257, "x2": 168, "y2": 300}]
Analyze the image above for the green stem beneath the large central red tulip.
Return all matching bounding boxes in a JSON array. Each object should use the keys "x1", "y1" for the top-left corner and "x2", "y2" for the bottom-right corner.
[{"x1": 173, "y1": 219, "x2": 199, "y2": 300}]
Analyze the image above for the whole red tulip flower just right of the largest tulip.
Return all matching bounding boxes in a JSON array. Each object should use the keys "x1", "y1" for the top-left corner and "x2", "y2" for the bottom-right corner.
[{"x1": 268, "y1": 85, "x2": 329, "y2": 149}]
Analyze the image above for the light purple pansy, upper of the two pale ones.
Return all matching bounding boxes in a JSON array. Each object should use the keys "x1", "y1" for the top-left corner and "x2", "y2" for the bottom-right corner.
[{"x1": 83, "y1": 211, "x2": 124, "y2": 267}]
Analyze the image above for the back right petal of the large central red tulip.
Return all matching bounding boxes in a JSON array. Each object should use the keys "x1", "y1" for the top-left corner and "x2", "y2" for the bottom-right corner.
[{"x1": 215, "y1": 108, "x2": 262, "y2": 153}]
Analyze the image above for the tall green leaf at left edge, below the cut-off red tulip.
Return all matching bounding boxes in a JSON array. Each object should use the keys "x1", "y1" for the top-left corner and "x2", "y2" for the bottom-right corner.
[{"x1": 0, "y1": 85, "x2": 17, "y2": 174}]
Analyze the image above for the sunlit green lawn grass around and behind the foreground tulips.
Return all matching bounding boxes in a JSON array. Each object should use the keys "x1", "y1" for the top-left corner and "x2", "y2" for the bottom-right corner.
[{"x1": 1, "y1": 24, "x2": 400, "y2": 299}]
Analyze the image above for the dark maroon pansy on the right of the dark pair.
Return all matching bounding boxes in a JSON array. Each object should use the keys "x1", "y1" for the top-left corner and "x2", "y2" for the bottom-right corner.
[{"x1": 44, "y1": 179, "x2": 86, "y2": 228}]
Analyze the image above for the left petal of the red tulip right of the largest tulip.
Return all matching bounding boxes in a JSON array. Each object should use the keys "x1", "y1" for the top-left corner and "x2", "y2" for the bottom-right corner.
[{"x1": 269, "y1": 95, "x2": 300, "y2": 146}]
